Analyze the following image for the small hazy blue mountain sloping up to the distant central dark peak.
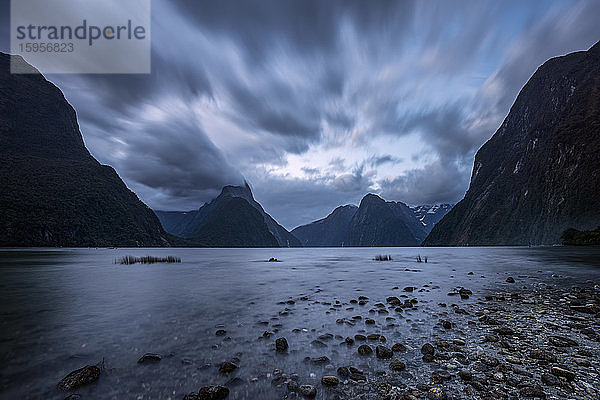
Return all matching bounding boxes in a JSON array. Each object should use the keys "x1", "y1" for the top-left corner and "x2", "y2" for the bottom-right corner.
[{"x1": 292, "y1": 205, "x2": 358, "y2": 247}]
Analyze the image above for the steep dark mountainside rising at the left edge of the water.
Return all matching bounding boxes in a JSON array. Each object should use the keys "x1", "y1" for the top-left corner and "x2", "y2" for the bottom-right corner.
[{"x1": 0, "y1": 53, "x2": 170, "y2": 247}]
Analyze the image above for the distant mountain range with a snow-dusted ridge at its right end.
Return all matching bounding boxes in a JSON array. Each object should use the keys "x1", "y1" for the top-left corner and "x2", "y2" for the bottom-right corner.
[{"x1": 292, "y1": 194, "x2": 452, "y2": 247}]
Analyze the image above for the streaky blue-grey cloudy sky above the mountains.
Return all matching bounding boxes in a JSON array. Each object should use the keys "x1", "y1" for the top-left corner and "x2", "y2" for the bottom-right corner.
[{"x1": 0, "y1": 0, "x2": 600, "y2": 229}]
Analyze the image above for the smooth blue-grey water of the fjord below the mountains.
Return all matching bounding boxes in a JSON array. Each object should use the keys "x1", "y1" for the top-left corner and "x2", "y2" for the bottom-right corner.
[{"x1": 0, "y1": 247, "x2": 600, "y2": 399}]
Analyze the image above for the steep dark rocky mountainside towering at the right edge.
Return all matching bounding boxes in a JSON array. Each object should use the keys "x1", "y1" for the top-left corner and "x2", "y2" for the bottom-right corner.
[{"x1": 424, "y1": 42, "x2": 600, "y2": 246}]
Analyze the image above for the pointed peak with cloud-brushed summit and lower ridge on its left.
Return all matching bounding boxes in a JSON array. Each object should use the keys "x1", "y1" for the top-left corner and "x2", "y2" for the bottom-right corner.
[{"x1": 155, "y1": 183, "x2": 301, "y2": 247}]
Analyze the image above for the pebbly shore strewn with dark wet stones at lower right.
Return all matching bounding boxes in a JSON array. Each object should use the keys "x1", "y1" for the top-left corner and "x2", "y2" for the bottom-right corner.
[{"x1": 58, "y1": 270, "x2": 600, "y2": 400}]
